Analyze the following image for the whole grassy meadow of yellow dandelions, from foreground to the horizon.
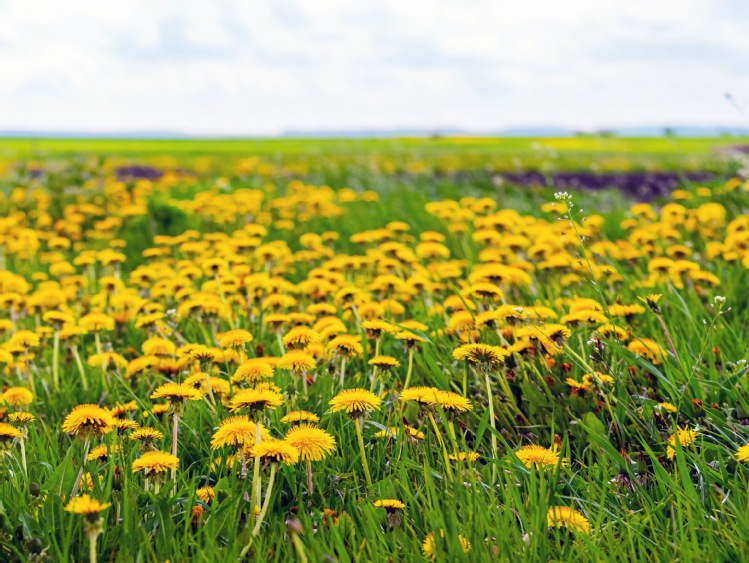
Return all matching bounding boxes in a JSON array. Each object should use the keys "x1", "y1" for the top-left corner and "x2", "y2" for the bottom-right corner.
[{"x1": 0, "y1": 139, "x2": 749, "y2": 562}]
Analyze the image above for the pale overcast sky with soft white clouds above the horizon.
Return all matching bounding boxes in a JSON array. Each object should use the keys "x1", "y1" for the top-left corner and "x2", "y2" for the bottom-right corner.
[{"x1": 0, "y1": 0, "x2": 749, "y2": 135}]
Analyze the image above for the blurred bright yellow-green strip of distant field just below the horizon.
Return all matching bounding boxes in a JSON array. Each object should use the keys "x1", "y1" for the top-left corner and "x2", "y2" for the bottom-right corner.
[{"x1": 0, "y1": 137, "x2": 749, "y2": 183}]
